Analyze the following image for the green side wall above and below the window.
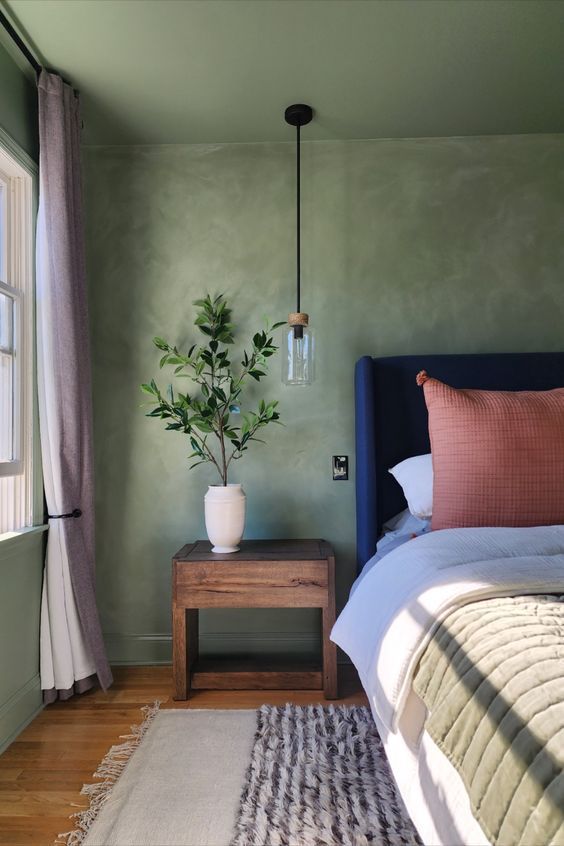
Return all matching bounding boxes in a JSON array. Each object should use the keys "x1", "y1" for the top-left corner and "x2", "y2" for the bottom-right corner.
[{"x1": 0, "y1": 39, "x2": 43, "y2": 752}]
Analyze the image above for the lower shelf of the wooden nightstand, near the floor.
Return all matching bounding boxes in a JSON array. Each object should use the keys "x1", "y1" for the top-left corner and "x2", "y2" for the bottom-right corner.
[{"x1": 191, "y1": 656, "x2": 323, "y2": 690}]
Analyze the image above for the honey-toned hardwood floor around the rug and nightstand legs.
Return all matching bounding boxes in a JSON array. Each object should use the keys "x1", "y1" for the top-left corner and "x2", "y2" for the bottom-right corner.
[{"x1": 0, "y1": 666, "x2": 366, "y2": 846}]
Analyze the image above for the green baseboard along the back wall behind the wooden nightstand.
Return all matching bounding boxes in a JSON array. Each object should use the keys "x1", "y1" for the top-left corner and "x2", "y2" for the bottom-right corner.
[{"x1": 104, "y1": 632, "x2": 321, "y2": 665}]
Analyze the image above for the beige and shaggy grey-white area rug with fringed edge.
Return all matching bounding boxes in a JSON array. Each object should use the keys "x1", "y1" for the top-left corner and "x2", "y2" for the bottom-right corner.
[{"x1": 61, "y1": 705, "x2": 420, "y2": 846}]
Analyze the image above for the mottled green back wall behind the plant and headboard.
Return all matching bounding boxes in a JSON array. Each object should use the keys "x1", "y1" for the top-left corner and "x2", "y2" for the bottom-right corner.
[{"x1": 85, "y1": 135, "x2": 564, "y2": 662}]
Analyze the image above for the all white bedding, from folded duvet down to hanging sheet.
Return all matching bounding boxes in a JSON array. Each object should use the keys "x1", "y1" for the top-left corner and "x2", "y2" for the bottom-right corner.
[{"x1": 331, "y1": 526, "x2": 564, "y2": 846}]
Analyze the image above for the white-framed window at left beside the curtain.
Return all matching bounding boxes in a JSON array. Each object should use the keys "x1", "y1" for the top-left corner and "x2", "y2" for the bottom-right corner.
[{"x1": 0, "y1": 142, "x2": 33, "y2": 534}]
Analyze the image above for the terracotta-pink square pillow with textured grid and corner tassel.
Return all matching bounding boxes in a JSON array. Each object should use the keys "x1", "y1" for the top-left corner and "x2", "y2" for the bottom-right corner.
[{"x1": 417, "y1": 370, "x2": 564, "y2": 529}]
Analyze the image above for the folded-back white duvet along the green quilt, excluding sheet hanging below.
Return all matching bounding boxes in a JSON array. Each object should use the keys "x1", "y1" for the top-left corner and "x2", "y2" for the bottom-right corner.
[{"x1": 331, "y1": 526, "x2": 564, "y2": 731}]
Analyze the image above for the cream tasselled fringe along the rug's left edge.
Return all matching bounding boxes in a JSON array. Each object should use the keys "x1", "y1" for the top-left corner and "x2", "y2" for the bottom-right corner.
[{"x1": 55, "y1": 699, "x2": 161, "y2": 846}]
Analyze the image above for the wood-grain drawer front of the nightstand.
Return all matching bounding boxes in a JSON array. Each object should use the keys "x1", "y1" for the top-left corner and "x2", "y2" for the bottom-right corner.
[{"x1": 174, "y1": 561, "x2": 329, "y2": 608}]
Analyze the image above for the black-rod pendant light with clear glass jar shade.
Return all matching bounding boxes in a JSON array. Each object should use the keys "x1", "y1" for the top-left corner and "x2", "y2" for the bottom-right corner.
[{"x1": 281, "y1": 103, "x2": 314, "y2": 385}]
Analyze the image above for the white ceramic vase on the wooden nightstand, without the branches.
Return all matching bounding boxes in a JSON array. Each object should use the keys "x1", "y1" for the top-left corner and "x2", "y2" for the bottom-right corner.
[{"x1": 204, "y1": 485, "x2": 247, "y2": 552}]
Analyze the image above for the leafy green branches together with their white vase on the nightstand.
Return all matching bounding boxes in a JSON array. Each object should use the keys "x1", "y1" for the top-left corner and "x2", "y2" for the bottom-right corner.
[{"x1": 141, "y1": 294, "x2": 283, "y2": 553}]
